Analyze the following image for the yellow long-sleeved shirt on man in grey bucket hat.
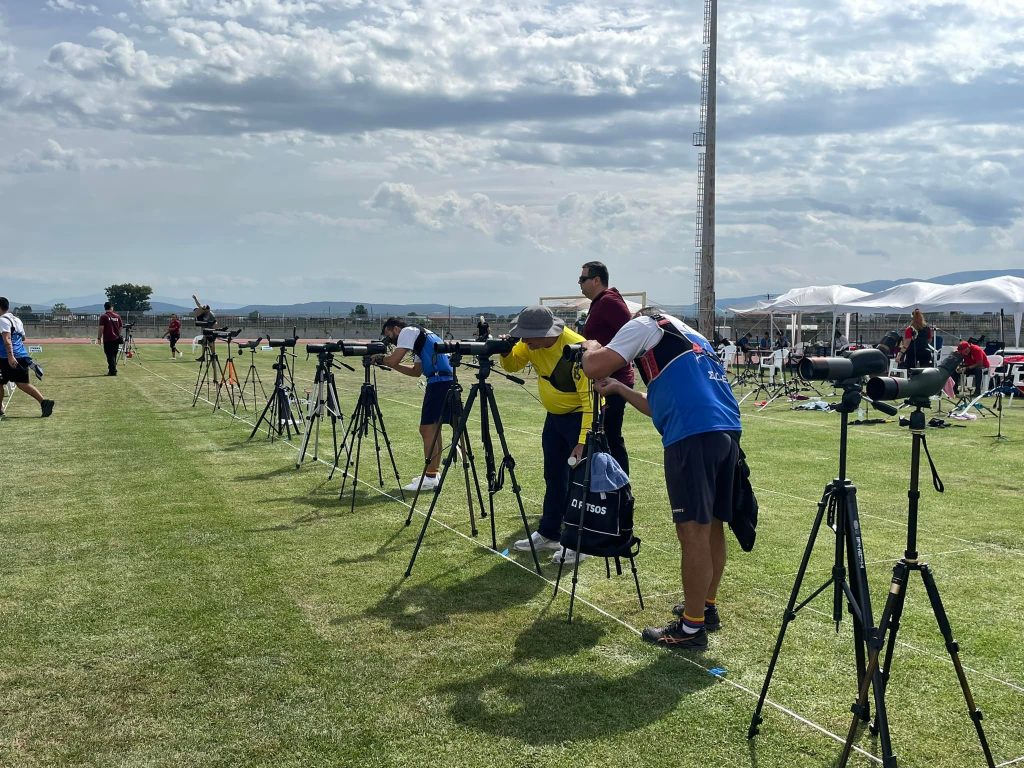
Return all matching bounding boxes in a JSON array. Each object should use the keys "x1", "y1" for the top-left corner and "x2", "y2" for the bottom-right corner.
[{"x1": 502, "y1": 328, "x2": 594, "y2": 442}]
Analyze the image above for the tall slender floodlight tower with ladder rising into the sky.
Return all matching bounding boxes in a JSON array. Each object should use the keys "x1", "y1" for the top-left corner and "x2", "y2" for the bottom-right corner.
[{"x1": 693, "y1": 0, "x2": 718, "y2": 339}]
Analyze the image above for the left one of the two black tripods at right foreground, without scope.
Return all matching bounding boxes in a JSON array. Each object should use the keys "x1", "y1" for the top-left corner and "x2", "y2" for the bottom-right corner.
[{"x1": 746, "y1": 377, "x2": 895, "y2": 753}]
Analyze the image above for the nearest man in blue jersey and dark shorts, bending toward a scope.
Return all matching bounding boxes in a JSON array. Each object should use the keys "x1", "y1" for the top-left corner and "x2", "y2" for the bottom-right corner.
[{"x1": 583, "y1": 315, "x2": 740, "y2": 650}]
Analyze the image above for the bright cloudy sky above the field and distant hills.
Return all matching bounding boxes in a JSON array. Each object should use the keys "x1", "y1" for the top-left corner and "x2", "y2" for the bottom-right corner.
[{"x1": 0, "y1": 0, "x2": 1024, "y2": 305}]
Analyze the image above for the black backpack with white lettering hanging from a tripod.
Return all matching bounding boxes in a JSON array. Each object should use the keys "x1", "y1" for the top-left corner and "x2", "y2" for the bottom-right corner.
[{"x1": 559, "y1": 459, "x2": 640, "y2": 557}]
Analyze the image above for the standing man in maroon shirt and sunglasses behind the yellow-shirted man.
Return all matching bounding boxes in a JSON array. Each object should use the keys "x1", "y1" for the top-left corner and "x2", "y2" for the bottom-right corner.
[{"x1": 580, "y1": 261, "x2": 634, "y2": 474}]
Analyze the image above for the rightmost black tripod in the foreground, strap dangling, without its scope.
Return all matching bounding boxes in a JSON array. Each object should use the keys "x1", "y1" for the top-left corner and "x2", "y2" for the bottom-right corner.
[{"x1": 838, "y1": 397, "x2": 995, "y2": 768}]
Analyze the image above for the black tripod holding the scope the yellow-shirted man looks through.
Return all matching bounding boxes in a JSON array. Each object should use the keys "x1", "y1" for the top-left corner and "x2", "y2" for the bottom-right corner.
[{"x1": 406, "y1": 354, "x2": 541, "y2": 578}]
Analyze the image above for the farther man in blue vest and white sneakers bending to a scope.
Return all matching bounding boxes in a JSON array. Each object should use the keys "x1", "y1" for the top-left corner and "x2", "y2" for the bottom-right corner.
[{"x1": 380, "y1": 317, "x2": 455, "y2": 490}]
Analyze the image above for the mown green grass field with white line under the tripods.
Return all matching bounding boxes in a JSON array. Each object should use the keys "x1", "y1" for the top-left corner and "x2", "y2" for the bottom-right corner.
[{"x1": 0, "y1": 345, "x2": 1024, "y2": 768}]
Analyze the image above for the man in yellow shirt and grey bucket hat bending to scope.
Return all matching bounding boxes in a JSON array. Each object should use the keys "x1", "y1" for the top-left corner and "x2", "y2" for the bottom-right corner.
[{"x1": 502, "y1": 305, "x2": 594, "y2": 563}]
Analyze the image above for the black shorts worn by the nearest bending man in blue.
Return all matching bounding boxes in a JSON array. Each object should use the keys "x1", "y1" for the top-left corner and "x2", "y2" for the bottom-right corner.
[{"x1": 665, "y1": 432, "x2": 739, "y2": 524}]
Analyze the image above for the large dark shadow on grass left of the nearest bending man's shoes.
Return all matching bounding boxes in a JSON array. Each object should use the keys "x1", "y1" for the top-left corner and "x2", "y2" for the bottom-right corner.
[{"x1": 442, "y1": 617, "x2": 716, "y2": 746}]
